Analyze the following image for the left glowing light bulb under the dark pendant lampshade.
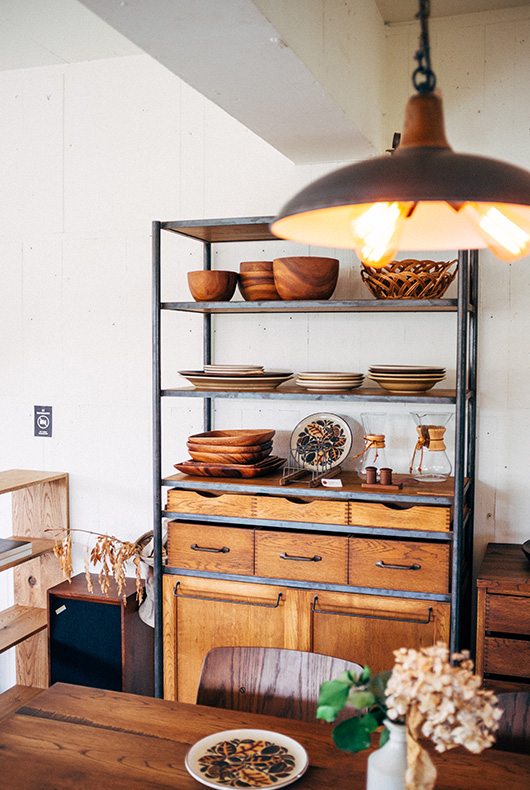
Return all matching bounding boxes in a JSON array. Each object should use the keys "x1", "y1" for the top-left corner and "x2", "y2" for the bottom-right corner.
[{"x1": 350, "y1": 202, "x2": 414, "y2": 269}]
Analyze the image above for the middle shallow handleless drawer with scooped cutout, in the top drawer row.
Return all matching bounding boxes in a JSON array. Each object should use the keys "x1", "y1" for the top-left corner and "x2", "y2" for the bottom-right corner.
[{"x1": 255, "y1": 496, "x2": 348, "y2": 526}]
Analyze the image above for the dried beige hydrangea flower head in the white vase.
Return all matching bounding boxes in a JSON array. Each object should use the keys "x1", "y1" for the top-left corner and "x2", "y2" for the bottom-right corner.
[{"x1": 386, "y1": 643, "x2": 502, "y2": 753}]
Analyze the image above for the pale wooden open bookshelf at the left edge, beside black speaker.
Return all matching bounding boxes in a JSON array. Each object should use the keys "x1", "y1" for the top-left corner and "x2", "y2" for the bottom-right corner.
[{"x1": 0, "y1": 469, "x2": 68, "y2": 688}]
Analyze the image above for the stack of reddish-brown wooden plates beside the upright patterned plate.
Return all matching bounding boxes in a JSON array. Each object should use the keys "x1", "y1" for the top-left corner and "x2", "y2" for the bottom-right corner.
[{"x1": 175, "y1": 430, "x2": 285, "y2": 477}]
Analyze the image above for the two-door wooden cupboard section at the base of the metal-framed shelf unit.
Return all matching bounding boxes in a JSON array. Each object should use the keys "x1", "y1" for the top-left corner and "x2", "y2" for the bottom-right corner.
[{"x1": 164, "y1": 575, "x2": 451, "y2": 702}]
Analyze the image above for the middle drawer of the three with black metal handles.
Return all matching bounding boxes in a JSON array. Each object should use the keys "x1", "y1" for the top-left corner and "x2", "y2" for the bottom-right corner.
[{"x1": 255, "y1": 530, "x2": 348, "y2": 584}]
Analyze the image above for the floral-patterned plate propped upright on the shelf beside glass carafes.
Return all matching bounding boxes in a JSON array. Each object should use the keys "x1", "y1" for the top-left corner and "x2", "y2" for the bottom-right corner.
[{"x1": 291, "y1": 412, "x2": 352, "y2": 472}]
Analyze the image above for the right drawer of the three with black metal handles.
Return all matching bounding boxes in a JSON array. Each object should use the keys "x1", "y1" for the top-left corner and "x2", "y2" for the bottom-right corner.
[{"x1": 349, "y1": 538, "x2": 450, "y2": 593}]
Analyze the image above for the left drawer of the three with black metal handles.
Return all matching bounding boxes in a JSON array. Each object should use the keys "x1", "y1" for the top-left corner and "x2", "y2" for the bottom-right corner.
[{"x1": 167, "y1": 521, "x2": 254, "y2": 574}]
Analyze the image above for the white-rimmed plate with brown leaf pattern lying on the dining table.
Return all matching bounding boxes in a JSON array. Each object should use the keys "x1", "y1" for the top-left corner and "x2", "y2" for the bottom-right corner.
[{"x1": 185, "y1": 730, "x2": 309, "y2": 789}]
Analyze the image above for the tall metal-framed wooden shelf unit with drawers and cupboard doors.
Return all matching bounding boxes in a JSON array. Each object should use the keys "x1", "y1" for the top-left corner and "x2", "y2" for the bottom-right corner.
[{"x1": 153, "y1": 217, "x2": 478, "y2": 700}]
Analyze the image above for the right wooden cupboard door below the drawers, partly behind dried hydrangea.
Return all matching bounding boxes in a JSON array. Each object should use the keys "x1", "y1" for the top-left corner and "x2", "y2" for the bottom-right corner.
[{"x1": 311, "y1": 590, "x2": 450, "y2": 672}]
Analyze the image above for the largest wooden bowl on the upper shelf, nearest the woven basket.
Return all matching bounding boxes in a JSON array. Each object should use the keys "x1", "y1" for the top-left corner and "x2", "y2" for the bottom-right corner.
[{"x1": 272, "y1": 256, "x2": 339, "y2": 300}]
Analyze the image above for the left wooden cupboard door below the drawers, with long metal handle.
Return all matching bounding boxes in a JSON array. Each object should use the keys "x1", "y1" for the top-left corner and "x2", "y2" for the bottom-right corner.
[{"x1": 164, "y1": 575, "x2": 310, "y2": 702}]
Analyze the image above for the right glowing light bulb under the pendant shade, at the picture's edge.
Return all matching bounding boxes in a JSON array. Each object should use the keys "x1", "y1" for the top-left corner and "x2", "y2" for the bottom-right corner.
[{"x1": 460, "y1": 203, "x2": 530, "y2": 262}]
